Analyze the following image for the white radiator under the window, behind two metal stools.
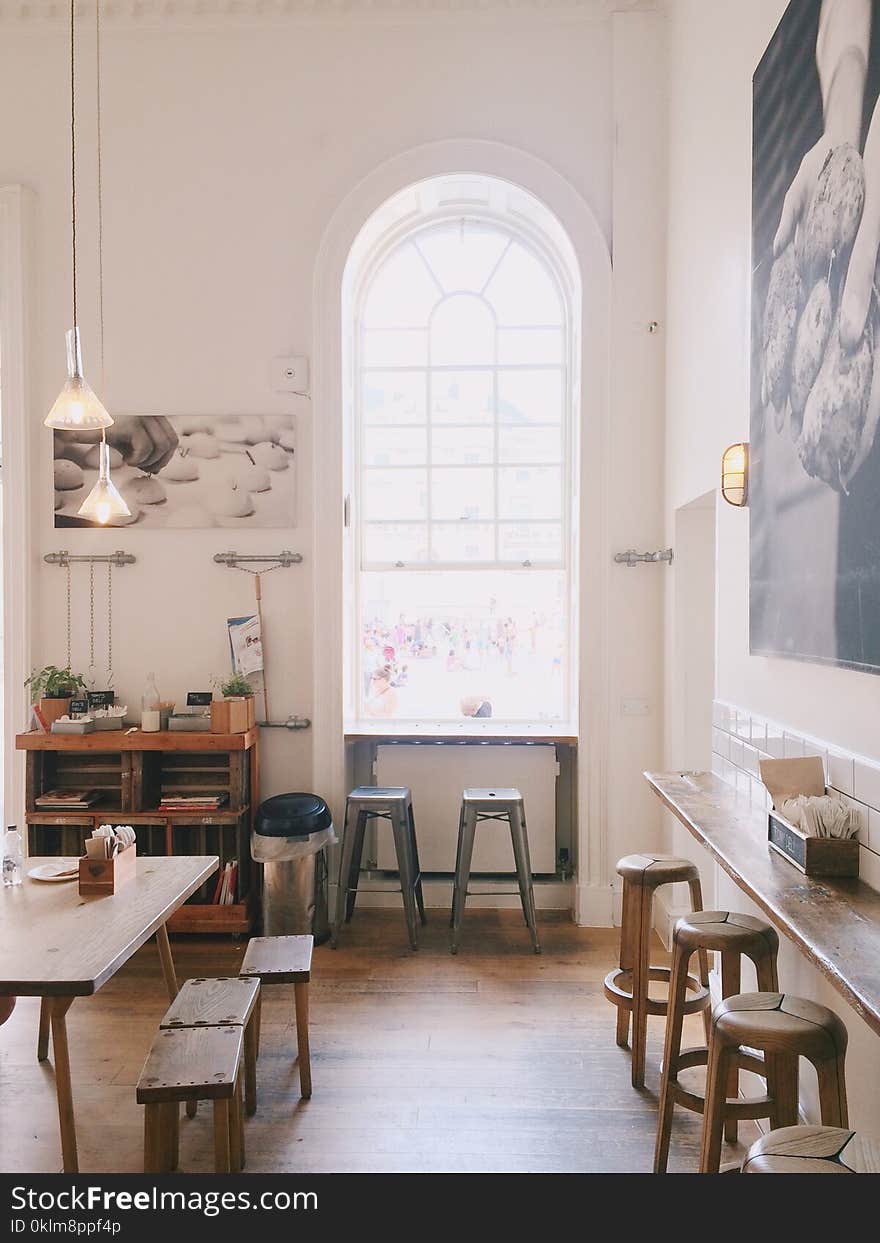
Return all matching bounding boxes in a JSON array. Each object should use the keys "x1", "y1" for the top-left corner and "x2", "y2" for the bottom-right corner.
[{"x1": 375, "y1": 743, "x2": 557, "y2": 874}]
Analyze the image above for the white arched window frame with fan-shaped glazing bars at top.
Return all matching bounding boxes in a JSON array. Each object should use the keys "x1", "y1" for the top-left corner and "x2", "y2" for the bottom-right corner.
[{"x1": 343, "y1": 175, "x2": 582, "y2": 721}]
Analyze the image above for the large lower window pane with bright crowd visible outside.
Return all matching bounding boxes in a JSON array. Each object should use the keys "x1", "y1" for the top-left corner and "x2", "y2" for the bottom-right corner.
[{"x1": 359, "y1": 569, "x2": 568, "y2": 721}]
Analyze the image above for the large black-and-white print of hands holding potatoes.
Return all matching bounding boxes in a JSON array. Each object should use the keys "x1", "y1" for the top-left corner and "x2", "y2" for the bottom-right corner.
[{"x1": 749, "y1": 0, "x2": 880, "y2": 672}]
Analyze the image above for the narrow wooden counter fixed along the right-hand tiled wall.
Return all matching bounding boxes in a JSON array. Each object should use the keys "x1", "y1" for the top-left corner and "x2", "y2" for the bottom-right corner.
[{"x1": 645, "y1": 773, "x2": 880, "y2": 1034}]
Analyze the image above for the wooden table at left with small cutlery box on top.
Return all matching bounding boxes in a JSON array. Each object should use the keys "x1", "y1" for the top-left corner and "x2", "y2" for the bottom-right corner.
[{"x1": 0, "y1": 855, "x2": 219, "y2": 1173}]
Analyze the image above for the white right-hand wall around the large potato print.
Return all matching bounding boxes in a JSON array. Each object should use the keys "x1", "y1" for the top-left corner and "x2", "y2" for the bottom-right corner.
[{"x1": 666, "y1": 0, "x2": 880, "y2": 1134}]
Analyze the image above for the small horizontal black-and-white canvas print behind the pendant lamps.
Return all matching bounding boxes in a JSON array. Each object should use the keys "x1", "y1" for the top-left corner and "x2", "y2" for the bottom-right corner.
[{"x1": 53, "y1": 414, "x2": 296, "y2": 530}]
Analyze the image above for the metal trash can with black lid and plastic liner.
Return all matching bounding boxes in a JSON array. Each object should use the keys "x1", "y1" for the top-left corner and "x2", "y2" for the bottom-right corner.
[{"x1": 251, "y1": 794, "x2": 336, "y2": 943}]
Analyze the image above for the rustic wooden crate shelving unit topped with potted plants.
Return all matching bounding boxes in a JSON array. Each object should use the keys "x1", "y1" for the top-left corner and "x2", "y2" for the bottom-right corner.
[{"x1": 15, "y1": 730, "x2": 260, "y2": 933}]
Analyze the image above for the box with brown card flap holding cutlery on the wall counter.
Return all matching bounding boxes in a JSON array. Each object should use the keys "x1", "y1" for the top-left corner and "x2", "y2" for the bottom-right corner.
[{"x1": 761, "y1": 756, "x2": 859, "y2": 878}]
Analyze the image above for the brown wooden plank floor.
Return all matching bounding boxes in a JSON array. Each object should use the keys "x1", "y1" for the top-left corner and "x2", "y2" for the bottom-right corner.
[{"x1": 0, "y1": 910, "x2": 756, "y2": 1173}]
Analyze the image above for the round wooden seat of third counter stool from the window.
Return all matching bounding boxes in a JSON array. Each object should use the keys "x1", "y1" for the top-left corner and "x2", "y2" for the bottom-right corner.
[{"x1": 713, "y1": 993, "x2": 846, "y2": 1060}]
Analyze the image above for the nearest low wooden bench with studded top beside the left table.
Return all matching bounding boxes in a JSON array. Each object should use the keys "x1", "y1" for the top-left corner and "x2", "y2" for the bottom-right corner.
[{"x1": 138, "y1": 1024, "x2": 245, "y2": 1173}]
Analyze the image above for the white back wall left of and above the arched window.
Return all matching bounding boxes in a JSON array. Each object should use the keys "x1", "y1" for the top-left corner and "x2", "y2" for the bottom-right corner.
[{"x1": 0, "y1": 5, "x2": 621, "y2": 793}]
